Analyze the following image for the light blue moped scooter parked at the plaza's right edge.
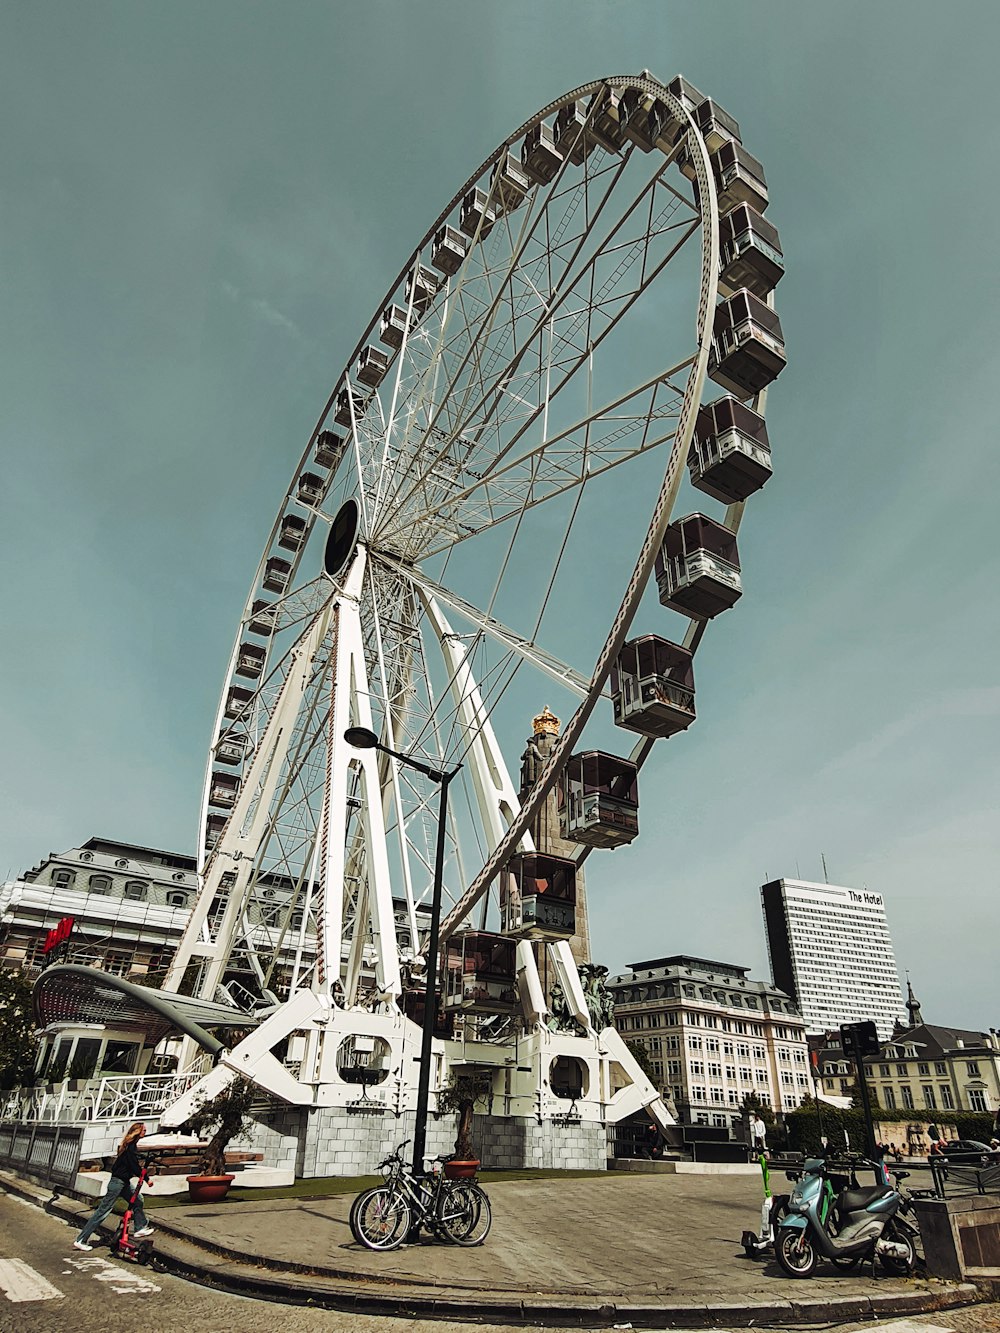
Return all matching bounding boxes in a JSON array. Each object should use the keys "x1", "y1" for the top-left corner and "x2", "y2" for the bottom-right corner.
[{"x1": 775, "y1": 1157, "x2": 916, "y2": 1277}]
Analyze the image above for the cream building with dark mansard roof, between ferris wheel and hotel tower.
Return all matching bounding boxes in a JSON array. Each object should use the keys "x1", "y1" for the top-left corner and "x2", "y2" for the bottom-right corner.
[{"x1": 608, "y1": 954, "x2": 811, "y2": 1128}]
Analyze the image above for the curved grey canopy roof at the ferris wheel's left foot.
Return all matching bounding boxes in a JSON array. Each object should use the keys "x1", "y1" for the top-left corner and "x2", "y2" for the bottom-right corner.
[{"x1": 33, "y1": 962, "x2": 257, "y2": 1054}]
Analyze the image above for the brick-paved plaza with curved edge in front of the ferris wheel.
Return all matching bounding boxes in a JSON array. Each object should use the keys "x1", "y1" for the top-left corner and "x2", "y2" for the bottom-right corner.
[{"x1": 4, "y1": 1173, "x2": 976, "y2": 1326}]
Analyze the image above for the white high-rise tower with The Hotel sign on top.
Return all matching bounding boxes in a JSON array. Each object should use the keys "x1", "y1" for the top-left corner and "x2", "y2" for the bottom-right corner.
[{"x1": 760, "y1": 880, "x2": 907, "y2": 1040}]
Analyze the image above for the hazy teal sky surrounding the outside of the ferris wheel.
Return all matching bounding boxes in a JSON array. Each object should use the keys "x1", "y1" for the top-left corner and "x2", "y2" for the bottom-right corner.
[{"x1": 0, "y1": 0, "x2": 1000, "y2": 1029}]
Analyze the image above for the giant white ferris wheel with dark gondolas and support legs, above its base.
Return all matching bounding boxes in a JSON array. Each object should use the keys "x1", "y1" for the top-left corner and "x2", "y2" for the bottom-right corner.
[{"x1": 167, "y1": 72, "x2": 784, "y2": 1050}]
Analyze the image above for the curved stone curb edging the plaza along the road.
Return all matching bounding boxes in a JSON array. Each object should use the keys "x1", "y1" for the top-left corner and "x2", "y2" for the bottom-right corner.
[{"x1": 0, "y1": 1173, "x2": 993, "y2": 1329}]
